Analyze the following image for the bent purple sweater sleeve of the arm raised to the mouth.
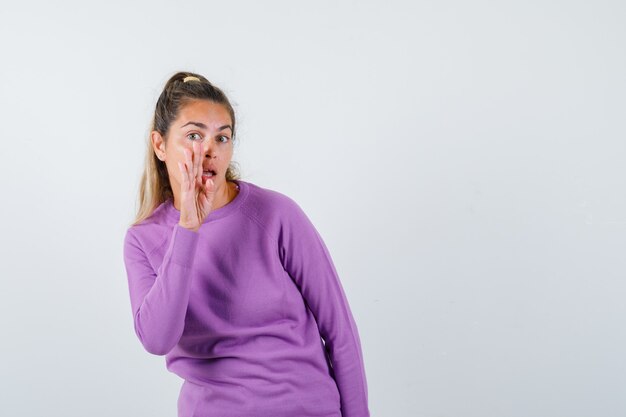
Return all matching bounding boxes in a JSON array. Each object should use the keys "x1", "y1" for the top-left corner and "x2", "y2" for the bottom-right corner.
[{"x1": 124, "y1": 224, "x2": 199, "y2": 355}]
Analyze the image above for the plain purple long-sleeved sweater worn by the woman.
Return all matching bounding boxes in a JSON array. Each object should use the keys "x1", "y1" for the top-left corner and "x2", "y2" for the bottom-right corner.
[{"x1": 124, "y1": 180, "x2": 369, "y2": 417}]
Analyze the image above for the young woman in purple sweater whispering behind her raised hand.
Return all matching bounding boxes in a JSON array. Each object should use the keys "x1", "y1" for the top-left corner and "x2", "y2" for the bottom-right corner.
[{"x1": 124, "y1": 72, "x2": 369, "y2": 417}]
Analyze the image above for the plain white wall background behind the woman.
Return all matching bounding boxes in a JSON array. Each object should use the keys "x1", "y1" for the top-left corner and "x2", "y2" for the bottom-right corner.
[{"x1": 0, "y1": 0, "x2": 626, "y2": 417}]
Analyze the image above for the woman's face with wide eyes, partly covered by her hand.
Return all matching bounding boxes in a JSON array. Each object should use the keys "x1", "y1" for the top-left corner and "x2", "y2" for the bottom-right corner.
[{"x1": 151, "y1": 100, "x2": 233, "y2": 201}]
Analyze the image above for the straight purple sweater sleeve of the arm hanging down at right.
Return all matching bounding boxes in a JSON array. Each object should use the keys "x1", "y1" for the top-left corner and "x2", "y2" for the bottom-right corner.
[{"x1": 279, "y1": 199, "x2": 370, "y2": 417}]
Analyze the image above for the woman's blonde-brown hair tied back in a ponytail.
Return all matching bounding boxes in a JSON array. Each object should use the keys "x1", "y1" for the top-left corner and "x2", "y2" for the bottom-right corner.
[{"x1": 132, "y1": 72, "x2": 240, "y2": 226}]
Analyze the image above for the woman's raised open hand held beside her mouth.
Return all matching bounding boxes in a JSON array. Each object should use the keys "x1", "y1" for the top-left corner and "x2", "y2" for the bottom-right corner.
[{"x1": 178, "y1": 142, "x2": 215, "y2": 232}]
